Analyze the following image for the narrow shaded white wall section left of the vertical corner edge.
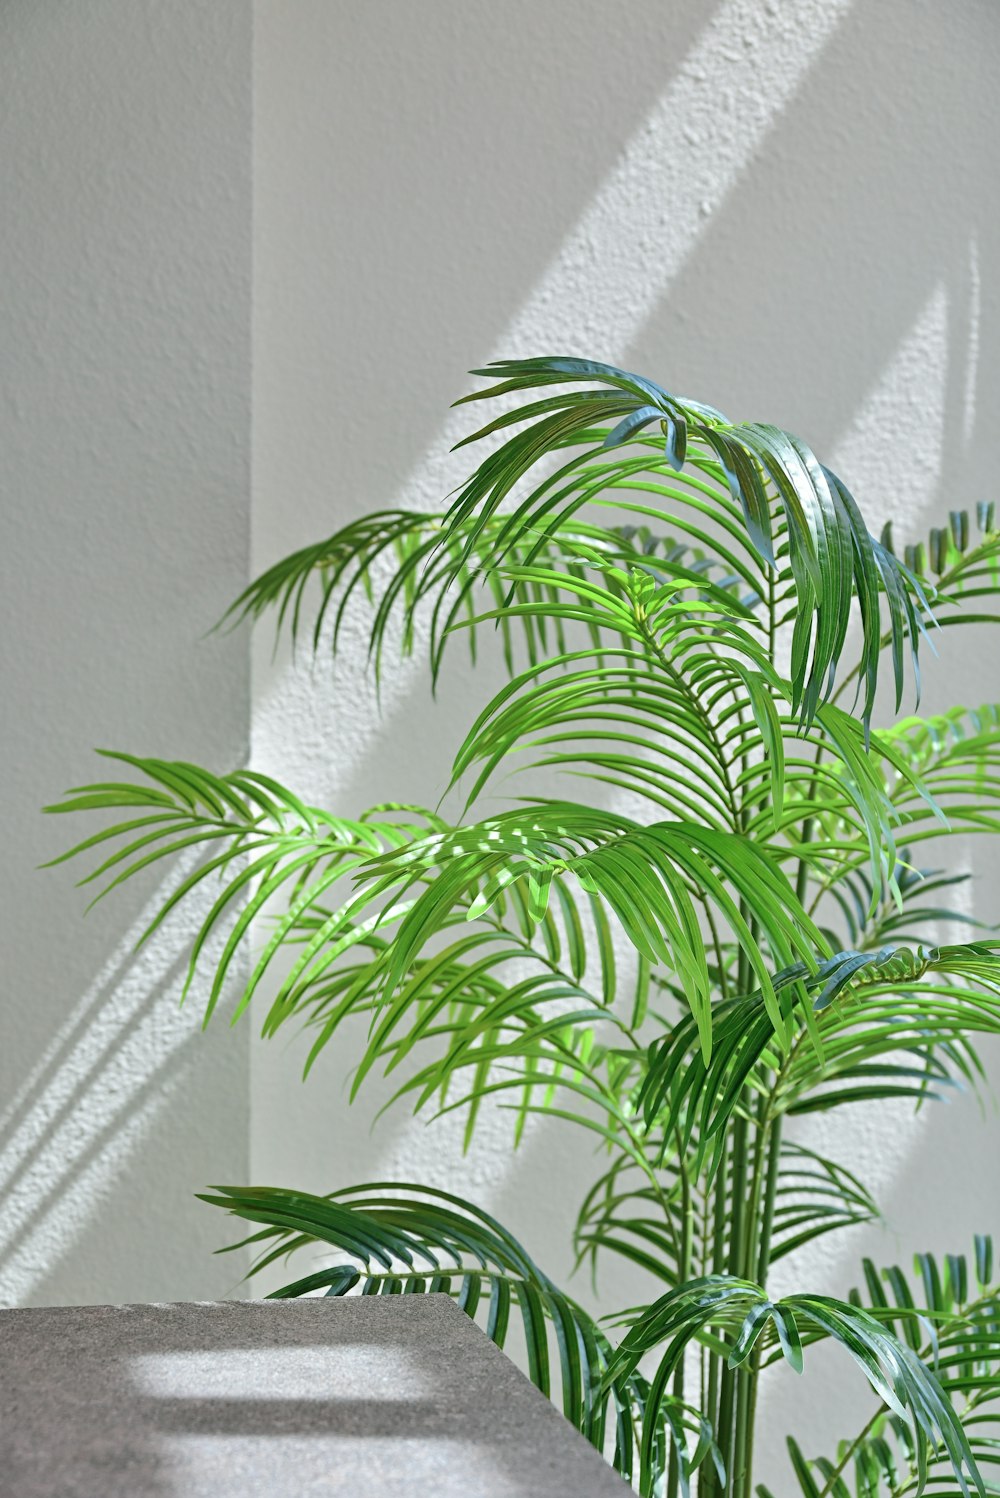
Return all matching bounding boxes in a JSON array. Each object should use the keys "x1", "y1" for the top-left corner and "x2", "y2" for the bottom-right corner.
[{"x1": 0, "y1": 0, "x2": 251, "y2": 1305}]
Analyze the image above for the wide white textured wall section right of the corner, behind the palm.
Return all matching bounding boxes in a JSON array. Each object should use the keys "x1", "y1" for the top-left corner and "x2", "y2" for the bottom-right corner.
[{"x1": 251, "y1": 0, "x2": 1000, "y2": 1492}]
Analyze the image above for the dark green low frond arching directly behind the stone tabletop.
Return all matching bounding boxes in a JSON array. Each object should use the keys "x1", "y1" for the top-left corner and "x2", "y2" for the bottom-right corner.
[{"x1": 201, "y1": 1182, "x2": 717, "y2": 1477}]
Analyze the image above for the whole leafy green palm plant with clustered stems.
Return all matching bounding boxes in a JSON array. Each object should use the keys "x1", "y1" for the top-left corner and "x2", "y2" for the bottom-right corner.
[{"x1": 52, "y1": 358, "x2": 1000, "y2": 1498}]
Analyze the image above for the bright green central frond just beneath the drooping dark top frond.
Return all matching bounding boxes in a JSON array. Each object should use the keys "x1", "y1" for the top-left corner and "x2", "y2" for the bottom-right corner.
[{"x1": 455, "y1": 556, "x2": 780, "y2": 827}]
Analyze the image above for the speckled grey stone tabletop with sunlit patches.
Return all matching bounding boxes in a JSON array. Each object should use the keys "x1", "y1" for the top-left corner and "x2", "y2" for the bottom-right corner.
[{"x1": 0, "y1": 1296, "x2": 629, "y2": 1498}]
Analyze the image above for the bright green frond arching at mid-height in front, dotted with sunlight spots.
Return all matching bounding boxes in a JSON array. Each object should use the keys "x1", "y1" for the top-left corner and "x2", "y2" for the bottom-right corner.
[{"x1": 359, "y1": 801, "x2": 825, "y2": 1055}]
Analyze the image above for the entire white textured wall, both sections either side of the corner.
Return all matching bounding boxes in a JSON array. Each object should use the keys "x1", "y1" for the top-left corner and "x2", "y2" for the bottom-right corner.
[{"x1": 0, "y1": 0, "x2": 1000, "y2": 1491}]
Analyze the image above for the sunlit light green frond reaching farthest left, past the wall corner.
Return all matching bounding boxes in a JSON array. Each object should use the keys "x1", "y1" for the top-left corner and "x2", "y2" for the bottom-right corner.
[{"x1": 54, "y1": 756, "x2": 679, "y2": 1114}]
